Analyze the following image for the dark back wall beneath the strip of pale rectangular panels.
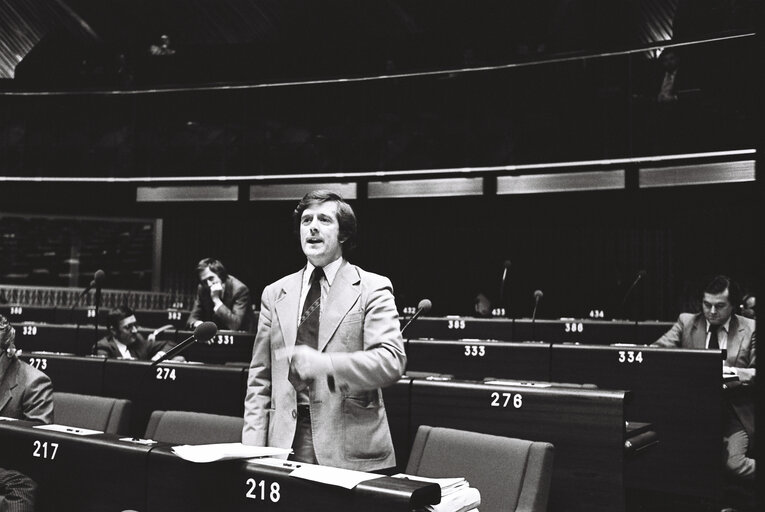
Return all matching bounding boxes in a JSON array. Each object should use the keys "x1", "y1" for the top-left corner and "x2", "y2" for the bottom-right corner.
[{"x1": 0, "y1": 177, "x2": 758, "y2": 320}]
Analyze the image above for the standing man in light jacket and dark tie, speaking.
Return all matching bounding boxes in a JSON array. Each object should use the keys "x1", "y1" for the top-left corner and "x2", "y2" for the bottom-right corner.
[{"x1": 242, "y1": 191, "x2": 406, "y2": 471}]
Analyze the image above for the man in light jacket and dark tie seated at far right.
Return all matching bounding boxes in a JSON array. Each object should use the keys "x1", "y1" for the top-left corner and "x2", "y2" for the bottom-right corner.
[{"x1": 652, "y1": 276, "x2": 756, "y2": 479}]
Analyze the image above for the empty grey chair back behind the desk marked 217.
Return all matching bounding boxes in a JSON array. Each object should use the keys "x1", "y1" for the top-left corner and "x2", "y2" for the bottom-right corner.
[{"x1": 53, "y1": 391, "x2": 133, "y2": 434}]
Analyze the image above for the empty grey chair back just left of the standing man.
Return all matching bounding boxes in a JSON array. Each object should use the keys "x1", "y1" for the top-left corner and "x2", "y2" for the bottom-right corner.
[{"x1": 145, "y1": 411, "x2": 244, "y2": 444}]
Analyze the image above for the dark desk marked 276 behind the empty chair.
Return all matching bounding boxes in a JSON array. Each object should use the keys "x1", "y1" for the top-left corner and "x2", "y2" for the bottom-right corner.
[{"x1": 411, "y1": 379, "x2": 629, "y2": 512}]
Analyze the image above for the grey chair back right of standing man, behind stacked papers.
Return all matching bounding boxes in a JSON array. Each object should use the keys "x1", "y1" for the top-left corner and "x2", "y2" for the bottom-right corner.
[{"x1": 406, "y1": 425, "x2": 553, "y2": 512}]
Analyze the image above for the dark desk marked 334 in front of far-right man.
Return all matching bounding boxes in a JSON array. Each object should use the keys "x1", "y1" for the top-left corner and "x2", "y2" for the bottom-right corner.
[{"x1": 551, "y1": 345, "x2": 723, "y2": 497}]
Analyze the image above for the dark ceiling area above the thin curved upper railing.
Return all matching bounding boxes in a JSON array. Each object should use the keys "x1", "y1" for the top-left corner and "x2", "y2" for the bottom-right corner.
[{"x1": 0, "y1": 0, "x2": 752, "y2": 89}]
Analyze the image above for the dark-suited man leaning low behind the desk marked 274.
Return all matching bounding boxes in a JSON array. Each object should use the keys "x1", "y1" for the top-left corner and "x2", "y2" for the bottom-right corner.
[{"x1": 93, "y1": 306, "x2": 185, "y2": 361}]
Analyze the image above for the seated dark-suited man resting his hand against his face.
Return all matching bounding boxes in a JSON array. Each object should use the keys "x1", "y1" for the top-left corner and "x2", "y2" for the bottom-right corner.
[{"x1": 188, "y1": 258, "x2": 256, "y2": 331}]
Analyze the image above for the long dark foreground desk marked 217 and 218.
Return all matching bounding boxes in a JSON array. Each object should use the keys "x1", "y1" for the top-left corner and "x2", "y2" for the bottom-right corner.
[{"x1": 0, "y1": 421, "x2": 440, "y2": 512}]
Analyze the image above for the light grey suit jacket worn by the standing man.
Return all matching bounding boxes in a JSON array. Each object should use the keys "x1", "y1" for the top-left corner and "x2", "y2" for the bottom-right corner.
[{"x1": 242, "y1": 262, "x2": 406, "y2": 471}]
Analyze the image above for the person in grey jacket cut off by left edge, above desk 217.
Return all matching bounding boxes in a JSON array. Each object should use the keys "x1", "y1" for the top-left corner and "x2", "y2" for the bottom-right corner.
[{"x1": 0, "y1": 315, "x2": 53, "y2": 423}]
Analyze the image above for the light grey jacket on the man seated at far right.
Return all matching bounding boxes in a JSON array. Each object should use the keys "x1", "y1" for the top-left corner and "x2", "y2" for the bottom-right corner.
[{"x1": 651, "y1": 313, "x2": 757, "y2": 382}]
